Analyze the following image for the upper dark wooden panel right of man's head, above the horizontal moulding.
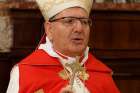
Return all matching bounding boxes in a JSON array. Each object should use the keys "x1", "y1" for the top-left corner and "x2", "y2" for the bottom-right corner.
[{"x1": 90, "y1": 11, "x2": 140, "y2": 50}]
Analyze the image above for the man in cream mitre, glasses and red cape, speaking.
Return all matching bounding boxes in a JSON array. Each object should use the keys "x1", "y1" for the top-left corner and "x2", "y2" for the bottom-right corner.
[{"x1": 7, "y1": 0, "x2": 119, "y2": 93}]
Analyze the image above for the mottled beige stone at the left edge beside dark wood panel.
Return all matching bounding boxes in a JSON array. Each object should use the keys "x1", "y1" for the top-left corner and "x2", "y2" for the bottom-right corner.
[{"x1": 0, "y1": 10, "x2": 13, "y2": 52}]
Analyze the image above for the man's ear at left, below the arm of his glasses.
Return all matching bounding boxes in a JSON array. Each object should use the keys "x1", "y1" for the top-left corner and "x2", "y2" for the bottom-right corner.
[{"x1": 44, "y1": 21, "x2": 52, "y2": 40}]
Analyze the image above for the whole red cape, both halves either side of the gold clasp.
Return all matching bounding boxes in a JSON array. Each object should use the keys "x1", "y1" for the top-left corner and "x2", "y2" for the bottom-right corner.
[{"x1": 18, "y1": 50, "x2": 120, "y2": 93}]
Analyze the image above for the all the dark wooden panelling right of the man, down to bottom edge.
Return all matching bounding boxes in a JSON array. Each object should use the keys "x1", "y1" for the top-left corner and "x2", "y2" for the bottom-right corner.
[{"x1": 89, "y1": 10, "x2": 140, "y2": 93}]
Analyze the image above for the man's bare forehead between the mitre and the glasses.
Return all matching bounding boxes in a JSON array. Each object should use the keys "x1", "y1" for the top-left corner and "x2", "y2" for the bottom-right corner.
[{"x1": 56, "y1": 7, "x2": 88, "y2": 17}]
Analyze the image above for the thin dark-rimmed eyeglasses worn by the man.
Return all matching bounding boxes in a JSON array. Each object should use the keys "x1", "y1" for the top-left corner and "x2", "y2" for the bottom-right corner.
[{"x1": 49, "y1": 17, "x2": 92, "y2": 27}]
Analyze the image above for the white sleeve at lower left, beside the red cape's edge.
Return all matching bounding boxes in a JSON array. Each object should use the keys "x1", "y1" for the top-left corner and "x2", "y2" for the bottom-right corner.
[{"x1": 6, "y1": 65, "x2": 19, "y2": 93}]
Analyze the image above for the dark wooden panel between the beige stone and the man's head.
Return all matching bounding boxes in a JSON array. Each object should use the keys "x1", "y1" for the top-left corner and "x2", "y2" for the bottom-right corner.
[{"x1": 10, "y1": 9, "x2": 43, "y2": 50}]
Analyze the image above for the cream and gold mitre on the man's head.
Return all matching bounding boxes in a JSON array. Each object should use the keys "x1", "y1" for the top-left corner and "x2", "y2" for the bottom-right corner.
[{"x1": 36, "y1": 0, "x2": 93, "y2": 21}]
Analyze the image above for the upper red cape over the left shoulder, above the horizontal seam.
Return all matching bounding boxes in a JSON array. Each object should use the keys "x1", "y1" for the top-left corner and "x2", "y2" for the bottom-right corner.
[{"x1": 19, "y1": 49, "x2": 59, "y2": 65}]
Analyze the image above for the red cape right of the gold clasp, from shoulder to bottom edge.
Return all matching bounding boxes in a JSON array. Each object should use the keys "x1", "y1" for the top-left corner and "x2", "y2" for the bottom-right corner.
[{"x1": 87, "y1": 53, "x2": 120, "y2": 93}]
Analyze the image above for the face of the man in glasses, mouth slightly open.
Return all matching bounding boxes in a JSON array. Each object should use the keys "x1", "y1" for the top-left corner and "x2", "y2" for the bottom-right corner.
[{"x1": 45, "y1": 7, "x2": 90, "y2": 56}]
